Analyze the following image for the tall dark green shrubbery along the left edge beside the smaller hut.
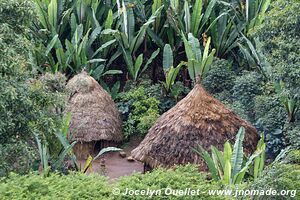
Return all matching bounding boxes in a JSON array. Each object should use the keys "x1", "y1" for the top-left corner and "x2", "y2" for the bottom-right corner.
[{"x1": 0, "y1": 5, "x2": 65, "y2": 176}]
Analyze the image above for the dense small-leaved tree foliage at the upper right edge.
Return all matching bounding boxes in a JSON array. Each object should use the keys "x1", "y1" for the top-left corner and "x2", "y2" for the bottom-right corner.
[{"x1": 253, "y1": 0, "x2": 300, "y2": 121}]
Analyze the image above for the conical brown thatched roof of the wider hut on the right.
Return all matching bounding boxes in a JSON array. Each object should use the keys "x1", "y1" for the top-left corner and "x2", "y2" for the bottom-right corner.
[{"x1": 132, "y1": 84, "x2": 259, "y2": 168}]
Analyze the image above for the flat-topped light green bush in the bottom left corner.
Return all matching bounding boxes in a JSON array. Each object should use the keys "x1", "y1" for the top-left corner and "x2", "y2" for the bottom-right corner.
[{"x1": 0, "y1": 174, "x2": 112, "y2": 200}]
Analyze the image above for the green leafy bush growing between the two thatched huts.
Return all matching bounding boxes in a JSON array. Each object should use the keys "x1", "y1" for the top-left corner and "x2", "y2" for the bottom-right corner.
[{"x1": 117, "y1": 86, "x2": 159, "y2": 138}]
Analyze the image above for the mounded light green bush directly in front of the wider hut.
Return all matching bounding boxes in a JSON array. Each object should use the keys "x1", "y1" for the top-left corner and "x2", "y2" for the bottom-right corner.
[{"x1": 115, "y1": 165, "x2": 224, "y2": 199}]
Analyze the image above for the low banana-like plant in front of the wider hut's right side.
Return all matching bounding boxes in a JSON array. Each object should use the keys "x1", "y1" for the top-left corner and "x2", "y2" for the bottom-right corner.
[{"x1": 194, "y1": 127, "x2": 266, "y2": 185}]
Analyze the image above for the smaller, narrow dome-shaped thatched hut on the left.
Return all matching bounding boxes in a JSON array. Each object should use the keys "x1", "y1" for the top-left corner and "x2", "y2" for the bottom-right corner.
[{"x1": 65, "y1": 72, "x2": 123, "y2": 159}]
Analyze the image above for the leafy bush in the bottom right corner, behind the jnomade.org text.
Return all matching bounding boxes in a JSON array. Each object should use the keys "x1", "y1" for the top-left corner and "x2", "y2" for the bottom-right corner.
[{"x1": 249, "y1": 159, "x2": 300, "y2": 200}]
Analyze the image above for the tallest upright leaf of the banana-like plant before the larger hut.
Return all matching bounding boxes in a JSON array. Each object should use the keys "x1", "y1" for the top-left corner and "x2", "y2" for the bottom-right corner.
[{"x1": 231, "y1": 127, "x2": 245, "y2": 177}]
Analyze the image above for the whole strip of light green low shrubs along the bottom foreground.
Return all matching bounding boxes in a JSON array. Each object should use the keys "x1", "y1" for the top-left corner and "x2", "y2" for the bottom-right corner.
[{"x1": 0, "y1": 165, "x2": 230, "y2": 200}]
